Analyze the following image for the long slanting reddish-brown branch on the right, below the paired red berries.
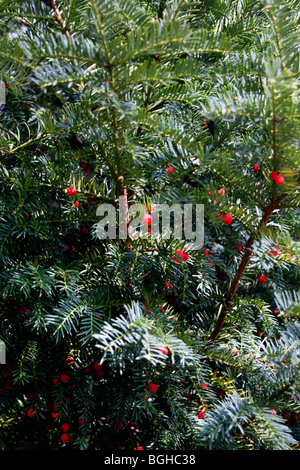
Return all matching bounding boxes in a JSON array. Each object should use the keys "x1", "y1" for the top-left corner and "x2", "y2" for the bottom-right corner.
[{"x1": 210, "y1": 199, "x2": 280, "y2": 341}]
